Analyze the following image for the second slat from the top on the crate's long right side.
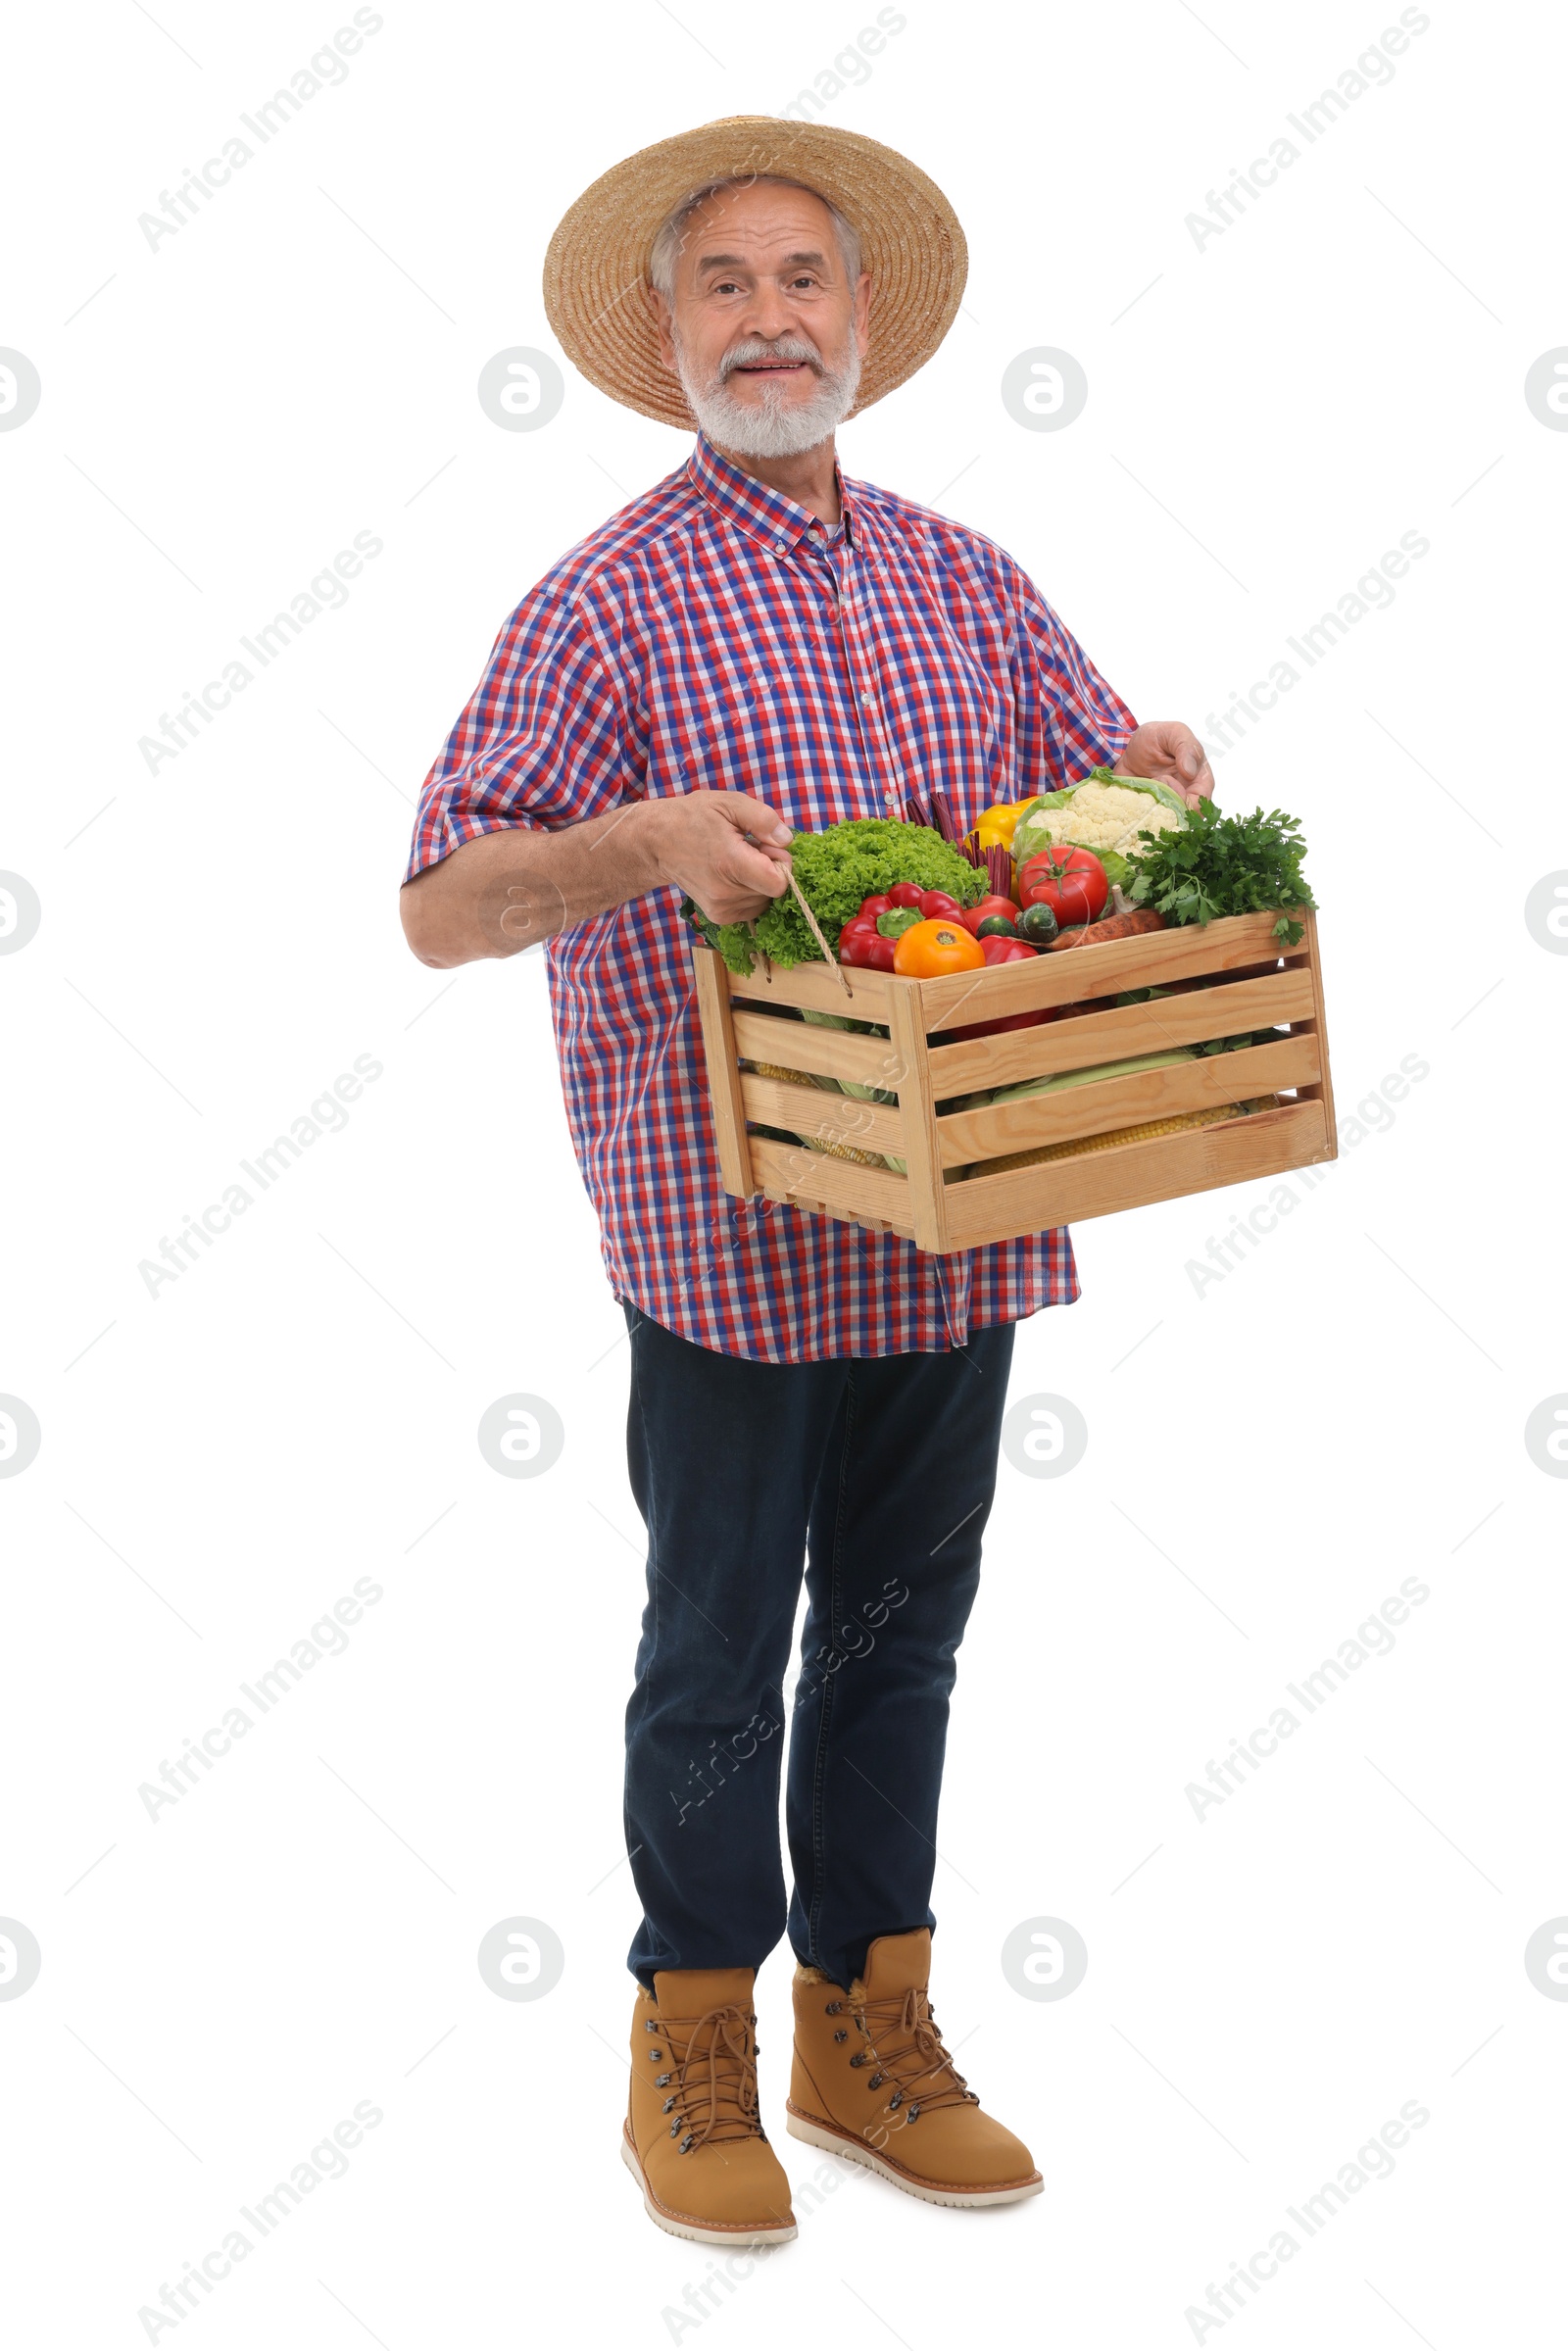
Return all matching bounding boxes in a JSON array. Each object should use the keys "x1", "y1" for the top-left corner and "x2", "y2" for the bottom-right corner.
[{"x1": 931, "y1": 964, "x2": 1316, "y2": 1101}]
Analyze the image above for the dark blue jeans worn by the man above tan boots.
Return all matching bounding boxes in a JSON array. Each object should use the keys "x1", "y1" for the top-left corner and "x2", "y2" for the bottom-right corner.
[{"x1": 625, "y1": 1307, "x2": 1013, "y2": 1986}]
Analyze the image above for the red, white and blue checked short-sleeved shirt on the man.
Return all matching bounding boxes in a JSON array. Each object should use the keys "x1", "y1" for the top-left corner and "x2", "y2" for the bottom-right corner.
[{"x1": 409, "y1": 440, "x2": 1133, "y2": 1363}]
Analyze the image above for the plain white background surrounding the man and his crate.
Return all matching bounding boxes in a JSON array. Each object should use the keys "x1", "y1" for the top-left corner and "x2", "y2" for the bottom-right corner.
[{"x1": 0, "y1": 0, "x2": 1568, "y2": 2351}]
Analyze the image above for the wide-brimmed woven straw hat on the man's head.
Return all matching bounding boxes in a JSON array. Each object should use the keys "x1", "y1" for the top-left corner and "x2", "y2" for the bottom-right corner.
[{"x1": 546, "y1": 116, "x2": 968, "y2": 430}]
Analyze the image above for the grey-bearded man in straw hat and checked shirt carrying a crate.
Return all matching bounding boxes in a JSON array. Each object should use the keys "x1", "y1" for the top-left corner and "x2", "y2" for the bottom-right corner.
[{"x1": 402, "y1": 118, "x2": 1213, "y2": 2245}]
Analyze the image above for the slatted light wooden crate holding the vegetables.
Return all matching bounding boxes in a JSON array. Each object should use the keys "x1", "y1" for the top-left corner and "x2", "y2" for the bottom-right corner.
[{"x1": 694, "y1": 914, "x2": 1336, "y2": 1253}]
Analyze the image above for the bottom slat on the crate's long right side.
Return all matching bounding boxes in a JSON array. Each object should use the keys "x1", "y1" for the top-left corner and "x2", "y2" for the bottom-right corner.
[{"x1": 948, "y1": 1102, "x2": 1333, "y2": 1250}]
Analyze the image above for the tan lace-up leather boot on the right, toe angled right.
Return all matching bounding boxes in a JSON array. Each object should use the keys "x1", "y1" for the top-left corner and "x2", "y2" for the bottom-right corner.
[{"x1": 785, "y1": 1928, "x2": 1044, "y2": 2205}]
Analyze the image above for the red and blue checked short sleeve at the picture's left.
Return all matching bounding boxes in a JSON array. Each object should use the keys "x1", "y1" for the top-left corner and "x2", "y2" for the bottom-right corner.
[{"x1": 405, "y1": 581, "x2": 635, "y2": 882}]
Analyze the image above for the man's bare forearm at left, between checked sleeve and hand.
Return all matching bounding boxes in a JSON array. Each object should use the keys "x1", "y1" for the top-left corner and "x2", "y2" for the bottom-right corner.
[{"x1": 400, "y1": 802, "x2": 670, "y2": 971}]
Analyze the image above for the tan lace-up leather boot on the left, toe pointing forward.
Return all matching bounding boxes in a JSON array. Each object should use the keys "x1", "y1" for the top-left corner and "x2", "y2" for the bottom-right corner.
[{"x1": 620, "y1": 1968, "x2": 795, "y2": 2245}]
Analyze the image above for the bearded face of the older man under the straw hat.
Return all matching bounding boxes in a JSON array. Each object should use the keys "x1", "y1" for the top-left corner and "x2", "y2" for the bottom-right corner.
[{"x1": 651, "y1": 181, "x2": 872, "y2": 456}]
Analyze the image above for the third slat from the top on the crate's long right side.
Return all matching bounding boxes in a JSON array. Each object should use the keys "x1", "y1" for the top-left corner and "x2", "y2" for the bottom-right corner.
[{"x1": 930, "y1": 1035, "x2": 1321, "y2": 1168}]
